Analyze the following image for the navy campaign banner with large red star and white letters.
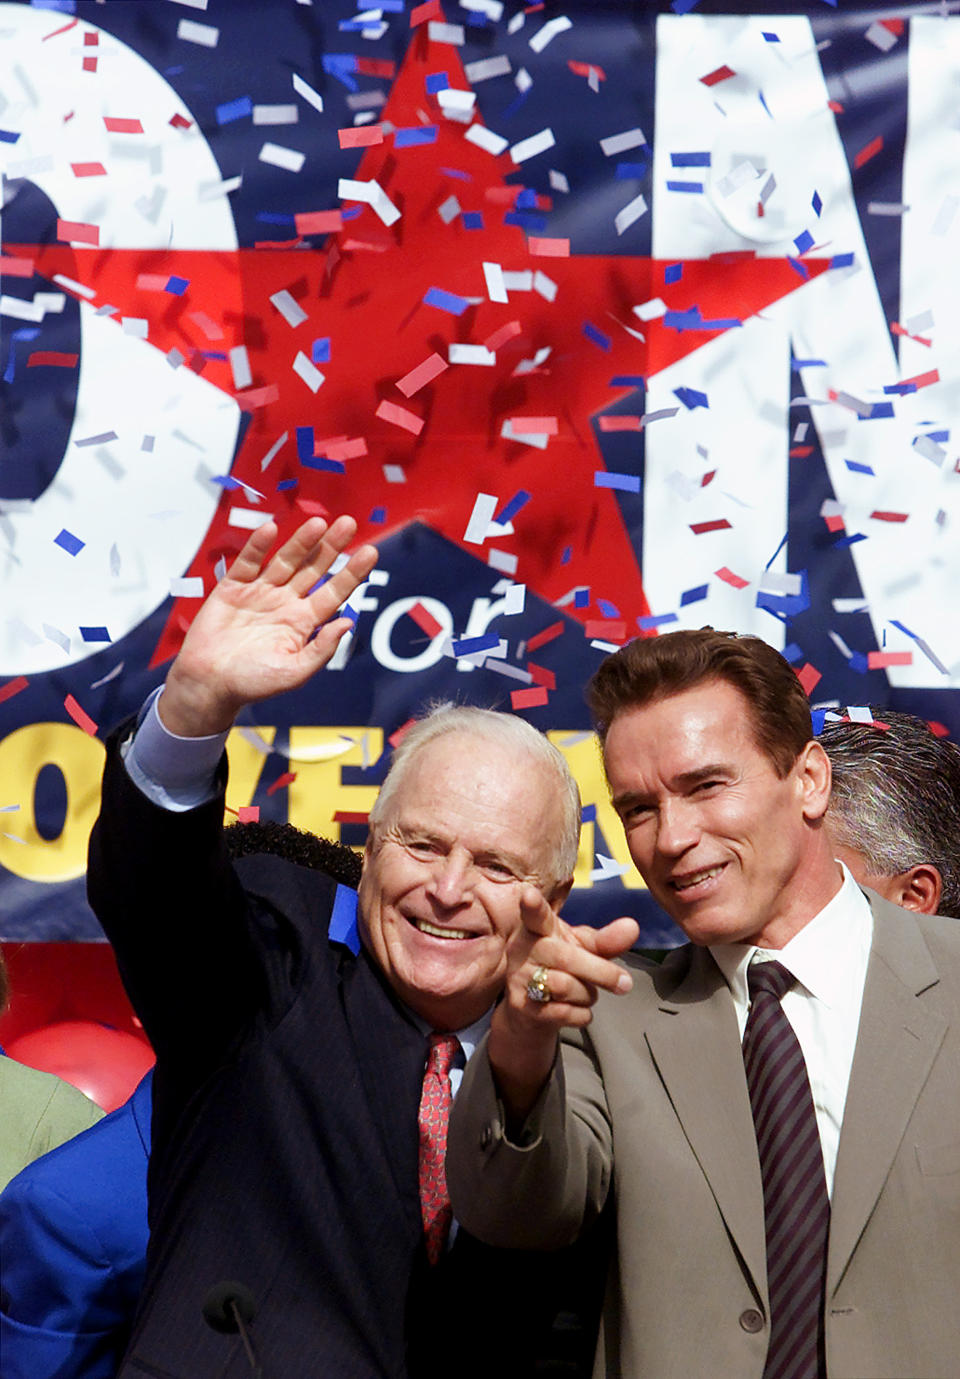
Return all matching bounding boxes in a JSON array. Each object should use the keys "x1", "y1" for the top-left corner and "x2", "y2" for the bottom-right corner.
[{"x1": 0, "y1": 0, "x2": 960, "y2": 946}]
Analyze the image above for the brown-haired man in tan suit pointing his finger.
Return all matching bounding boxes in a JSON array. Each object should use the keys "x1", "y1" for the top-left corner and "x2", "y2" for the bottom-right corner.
[{"x1": 447, "y1": 629, "x2": 960, "y2": 1379}]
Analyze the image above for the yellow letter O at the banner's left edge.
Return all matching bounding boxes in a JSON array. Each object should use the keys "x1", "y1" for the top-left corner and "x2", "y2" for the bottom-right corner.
[{"x1": 0, "y1": 723, "x2": 105, "y2": 881}]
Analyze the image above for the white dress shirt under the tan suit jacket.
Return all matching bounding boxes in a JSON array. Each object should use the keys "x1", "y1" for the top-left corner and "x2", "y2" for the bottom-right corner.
[{"x1": 710, "y1": 862, "x2": 873, "y2": 1194}]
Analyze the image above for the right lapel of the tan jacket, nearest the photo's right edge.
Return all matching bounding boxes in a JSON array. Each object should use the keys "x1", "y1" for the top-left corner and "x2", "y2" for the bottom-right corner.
[{"x1": 828, "y1": 894, "x2": 946, "y2": 1296}]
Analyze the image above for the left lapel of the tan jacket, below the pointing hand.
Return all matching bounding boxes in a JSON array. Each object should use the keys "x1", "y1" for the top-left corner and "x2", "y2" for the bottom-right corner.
[{"x1": 646, "y1": 949, "x2": 767, "y2": 1298}]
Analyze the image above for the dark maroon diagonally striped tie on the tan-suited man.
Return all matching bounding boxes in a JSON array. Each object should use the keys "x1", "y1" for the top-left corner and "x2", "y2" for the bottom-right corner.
[{"x1": 743, "y1": 963, "x2": 830, "y2": 1379}]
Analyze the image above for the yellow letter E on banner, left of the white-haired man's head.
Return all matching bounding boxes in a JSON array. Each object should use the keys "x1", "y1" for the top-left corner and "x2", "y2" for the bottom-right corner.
[{"x1": 287, "y1": 727, "x2": 383, "y2": 841}]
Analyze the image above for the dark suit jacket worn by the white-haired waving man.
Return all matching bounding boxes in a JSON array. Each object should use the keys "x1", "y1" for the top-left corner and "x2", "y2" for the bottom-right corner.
[{"x1": 88, "y1": 747, "x2": 601, "y2": 1379}]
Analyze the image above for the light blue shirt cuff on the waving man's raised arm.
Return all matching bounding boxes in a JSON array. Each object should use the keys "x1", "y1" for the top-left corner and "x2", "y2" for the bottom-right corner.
[{"x1": 120, "y1": 685, "x2": 228, "y2": 814}]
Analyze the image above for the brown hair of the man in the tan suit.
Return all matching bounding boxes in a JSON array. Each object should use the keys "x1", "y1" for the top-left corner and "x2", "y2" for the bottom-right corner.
[{"x1": 586, "y1": 627, "x2": 812, "y2": 778}]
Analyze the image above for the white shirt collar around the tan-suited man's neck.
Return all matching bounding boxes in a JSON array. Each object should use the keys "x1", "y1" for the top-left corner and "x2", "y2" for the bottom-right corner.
[{"x1": 710, "y1": 862, "x2": 873, "y2": 1007}]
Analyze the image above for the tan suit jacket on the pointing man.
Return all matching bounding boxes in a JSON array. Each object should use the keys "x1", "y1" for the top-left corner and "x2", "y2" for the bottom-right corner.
[{"x1": 447, "y1": 892, "x2": 960, "y2": 1379}]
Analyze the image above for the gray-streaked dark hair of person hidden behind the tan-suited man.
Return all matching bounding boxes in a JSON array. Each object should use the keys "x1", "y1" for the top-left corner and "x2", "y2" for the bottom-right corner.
[{"x1": 819, "y1": 709, "x2": 960, "y2": 917}]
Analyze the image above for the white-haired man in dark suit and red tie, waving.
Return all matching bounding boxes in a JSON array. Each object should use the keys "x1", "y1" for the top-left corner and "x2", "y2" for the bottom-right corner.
[{"x1": 90, "y1": 519, "x2": 593, "y2": 1379}]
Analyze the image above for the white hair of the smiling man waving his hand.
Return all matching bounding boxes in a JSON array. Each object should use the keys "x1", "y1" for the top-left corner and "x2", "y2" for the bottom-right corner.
[{"x1": 370, "y1": 702, "x2": 581, "y2": 883}]
